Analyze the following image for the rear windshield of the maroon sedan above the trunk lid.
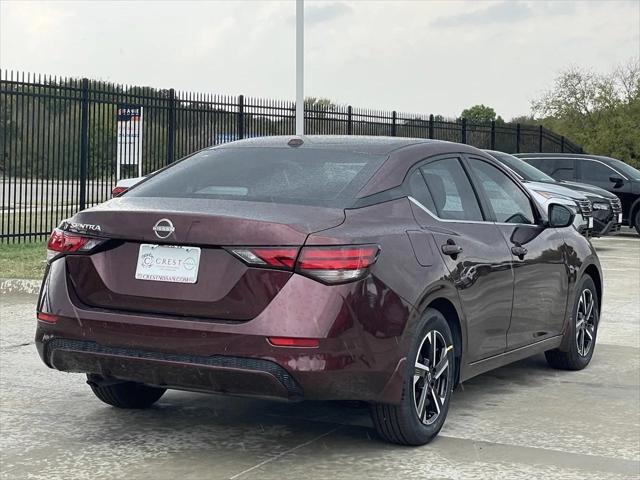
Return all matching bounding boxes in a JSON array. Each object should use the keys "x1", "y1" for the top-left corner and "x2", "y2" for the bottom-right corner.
[{"x1": 126, "y1": 147, "x2": 386, "y2": 208}]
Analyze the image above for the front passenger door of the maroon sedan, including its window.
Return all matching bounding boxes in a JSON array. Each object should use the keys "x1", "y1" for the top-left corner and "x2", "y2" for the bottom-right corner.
[{"x1": 466, "y1": 156, "x2": 573, "y2": 350}]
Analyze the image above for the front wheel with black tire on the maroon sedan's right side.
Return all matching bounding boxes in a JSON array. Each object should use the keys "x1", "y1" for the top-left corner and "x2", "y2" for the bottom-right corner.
[{"x1": 544, "y1": 275, "x2": 600, "y2": 370}]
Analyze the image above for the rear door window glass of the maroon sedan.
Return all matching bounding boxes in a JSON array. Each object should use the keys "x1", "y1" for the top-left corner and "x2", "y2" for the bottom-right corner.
[{"x1": 421, "y1": 158, "x2": 483, "y2": 220}]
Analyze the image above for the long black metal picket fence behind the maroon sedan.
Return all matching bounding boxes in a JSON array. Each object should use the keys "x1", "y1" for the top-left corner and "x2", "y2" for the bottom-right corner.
[{"x1": 0, "y1": 71, "x2": 581, "y2": 243}]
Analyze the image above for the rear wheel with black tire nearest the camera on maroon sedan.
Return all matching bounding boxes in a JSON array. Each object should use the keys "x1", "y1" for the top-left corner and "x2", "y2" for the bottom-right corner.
[{"x1": 371, "y1": 309, "x2": 456, "y2": 445}]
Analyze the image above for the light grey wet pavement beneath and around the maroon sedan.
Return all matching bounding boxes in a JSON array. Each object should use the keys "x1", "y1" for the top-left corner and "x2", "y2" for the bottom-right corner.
[{"x1": 0, "y1": 235, "x2": 640, "y2": 480}]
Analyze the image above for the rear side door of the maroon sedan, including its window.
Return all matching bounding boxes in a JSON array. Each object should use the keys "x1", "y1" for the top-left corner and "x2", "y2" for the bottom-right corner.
[{"x1": 408, "y1": 156, "x2": 513, "y2": 362}]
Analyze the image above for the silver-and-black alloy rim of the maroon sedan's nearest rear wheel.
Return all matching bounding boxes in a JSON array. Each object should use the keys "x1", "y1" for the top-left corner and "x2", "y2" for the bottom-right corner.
[{"x1": 413, "y1": 330, "x2": 453, "y2": 425}]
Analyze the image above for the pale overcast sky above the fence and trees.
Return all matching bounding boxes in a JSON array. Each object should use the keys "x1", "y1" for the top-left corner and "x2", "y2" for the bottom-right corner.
[{"x1": 0, "y1": 0, "x2": 640, "y2": 119}]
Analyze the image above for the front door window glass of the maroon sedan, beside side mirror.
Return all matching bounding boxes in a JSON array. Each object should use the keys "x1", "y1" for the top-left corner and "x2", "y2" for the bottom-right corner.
[{"x1": 471, "y1": 160, "x2": 535, "y2": 223}]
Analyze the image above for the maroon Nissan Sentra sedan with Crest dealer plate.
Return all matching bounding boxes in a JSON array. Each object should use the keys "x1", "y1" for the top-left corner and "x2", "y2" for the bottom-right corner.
[{"x1": 36, "y1": 136, "x2": 602, "y2": 445}]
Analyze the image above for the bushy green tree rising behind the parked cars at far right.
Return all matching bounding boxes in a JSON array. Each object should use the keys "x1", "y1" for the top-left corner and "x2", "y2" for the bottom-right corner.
[{"x1": 532, "y1": 58, "x2": 640, "y2": 167}]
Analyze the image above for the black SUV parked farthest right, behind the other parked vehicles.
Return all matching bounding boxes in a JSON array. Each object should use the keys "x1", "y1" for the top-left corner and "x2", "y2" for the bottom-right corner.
[{"x1": 516, "y1": 153, "x2": 640, "y2": 234}]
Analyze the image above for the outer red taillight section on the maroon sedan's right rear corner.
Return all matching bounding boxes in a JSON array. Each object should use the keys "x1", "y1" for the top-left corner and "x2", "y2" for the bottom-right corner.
[{"x1": 296, "y1": 245, "x2": 380, "y2": 283}]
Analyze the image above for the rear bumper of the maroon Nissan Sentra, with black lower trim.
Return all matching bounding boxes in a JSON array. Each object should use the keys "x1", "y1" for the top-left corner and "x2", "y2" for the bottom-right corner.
[{"x1": 36, "y1": 259, "x2": 415, "y2": 403}]
